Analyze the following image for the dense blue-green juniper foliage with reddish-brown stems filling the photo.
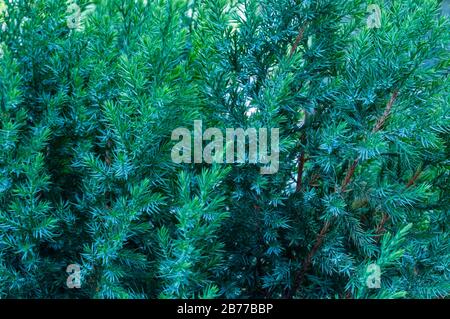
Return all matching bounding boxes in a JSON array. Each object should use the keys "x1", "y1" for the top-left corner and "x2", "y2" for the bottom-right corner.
[{"x1": 0, "y1": 0, "x2": 450, "y2": 298}]
